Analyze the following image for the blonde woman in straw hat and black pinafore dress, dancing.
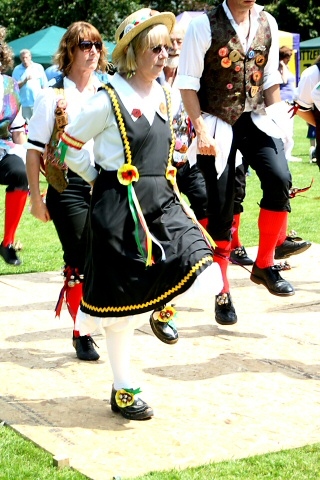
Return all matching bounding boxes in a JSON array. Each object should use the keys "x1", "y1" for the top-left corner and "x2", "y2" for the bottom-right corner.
[{"x1": 60, "y1": 8, "x2": 222, "y2": 420}]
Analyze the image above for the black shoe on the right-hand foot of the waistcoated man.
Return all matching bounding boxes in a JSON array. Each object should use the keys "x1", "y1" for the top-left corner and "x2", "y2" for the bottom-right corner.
[{"x1": 250, "y1": 263, "x2": 295, "y2": 297}]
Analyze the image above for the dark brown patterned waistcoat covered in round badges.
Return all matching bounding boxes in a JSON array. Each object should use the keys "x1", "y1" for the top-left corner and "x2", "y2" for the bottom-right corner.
[{"x1": 198, "y1": 5, "x2": 271, "y2": 125}]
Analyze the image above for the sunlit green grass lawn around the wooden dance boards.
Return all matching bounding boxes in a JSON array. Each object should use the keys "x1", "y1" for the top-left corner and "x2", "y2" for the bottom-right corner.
[{"x1": 0, "y1": 114, "x2": 320, "y2": 480}]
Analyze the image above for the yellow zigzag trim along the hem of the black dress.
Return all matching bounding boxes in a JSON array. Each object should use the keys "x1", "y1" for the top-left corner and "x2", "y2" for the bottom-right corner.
[{"x1": 81, "y1": 256, "x2": 213, "y2": 313}]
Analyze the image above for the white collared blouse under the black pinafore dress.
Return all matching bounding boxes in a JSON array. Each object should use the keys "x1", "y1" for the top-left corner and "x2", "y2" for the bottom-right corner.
[{"x1": 61, "y1": 73, "x2": 168, "y2": 182}]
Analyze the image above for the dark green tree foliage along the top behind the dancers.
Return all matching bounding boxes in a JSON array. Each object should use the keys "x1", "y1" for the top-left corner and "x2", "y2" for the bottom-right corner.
[{"x1": 0, "y1": 0, "x2": 320, "y2": 41}]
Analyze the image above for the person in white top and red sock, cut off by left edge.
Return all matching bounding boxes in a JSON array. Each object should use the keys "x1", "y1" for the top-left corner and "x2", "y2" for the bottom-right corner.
[{"x1": 0, "y1": 27, "x2": 28, "y2": 266}]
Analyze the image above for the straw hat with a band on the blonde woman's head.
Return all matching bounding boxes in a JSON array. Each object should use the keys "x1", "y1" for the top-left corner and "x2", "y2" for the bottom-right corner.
[{"x1": 112, "y1": 8, "x2": 175, "y2": 63}]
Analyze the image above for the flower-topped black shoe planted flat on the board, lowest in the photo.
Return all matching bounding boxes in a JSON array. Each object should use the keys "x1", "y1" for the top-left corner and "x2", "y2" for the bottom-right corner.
[{"x1": 110, "y1": 387, "x2": 153, "y2": 420}]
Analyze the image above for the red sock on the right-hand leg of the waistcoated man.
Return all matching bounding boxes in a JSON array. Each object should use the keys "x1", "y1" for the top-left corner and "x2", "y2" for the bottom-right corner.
[{"x1": 255, "y1": 208, "x2": 288, "y2": 268}]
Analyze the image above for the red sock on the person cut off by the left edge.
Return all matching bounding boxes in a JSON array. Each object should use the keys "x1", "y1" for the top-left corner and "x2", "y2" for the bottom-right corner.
[{"x1": 2, "y1": 190, "x2": 28, "y2": 247}]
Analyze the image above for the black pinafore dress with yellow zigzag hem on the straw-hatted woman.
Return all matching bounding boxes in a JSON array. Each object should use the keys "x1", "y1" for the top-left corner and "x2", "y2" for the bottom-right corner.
[{"x1": 81, "y1": 85, "x2": 213, "y2": 317}]
